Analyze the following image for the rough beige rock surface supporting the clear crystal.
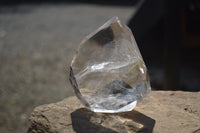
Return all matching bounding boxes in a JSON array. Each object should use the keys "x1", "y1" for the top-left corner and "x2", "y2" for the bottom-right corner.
[{"x1": 28, "y1": 91, "x2": 200, "y2": 133}]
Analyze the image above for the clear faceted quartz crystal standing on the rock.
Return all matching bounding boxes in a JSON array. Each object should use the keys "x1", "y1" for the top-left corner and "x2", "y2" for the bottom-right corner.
[{"x1": 69, "y1": 17, "x2": 151, "y2": 113}]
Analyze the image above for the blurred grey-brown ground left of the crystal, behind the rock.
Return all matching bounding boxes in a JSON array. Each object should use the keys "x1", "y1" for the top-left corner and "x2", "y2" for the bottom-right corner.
[{"x1": 0, "y1": 3, "x2": 135, "y2": 133}]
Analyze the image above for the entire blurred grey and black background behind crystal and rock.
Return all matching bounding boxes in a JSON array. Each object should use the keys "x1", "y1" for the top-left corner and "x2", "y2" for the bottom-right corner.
[{"x1": 0, "y1": 0, "x2": 200, "y2": 133}]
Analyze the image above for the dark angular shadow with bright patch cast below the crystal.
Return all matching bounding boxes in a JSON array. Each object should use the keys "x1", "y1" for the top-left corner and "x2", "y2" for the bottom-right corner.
[{"x1": 71, "y1": 108, "x2": 156, "y2": 133}]
